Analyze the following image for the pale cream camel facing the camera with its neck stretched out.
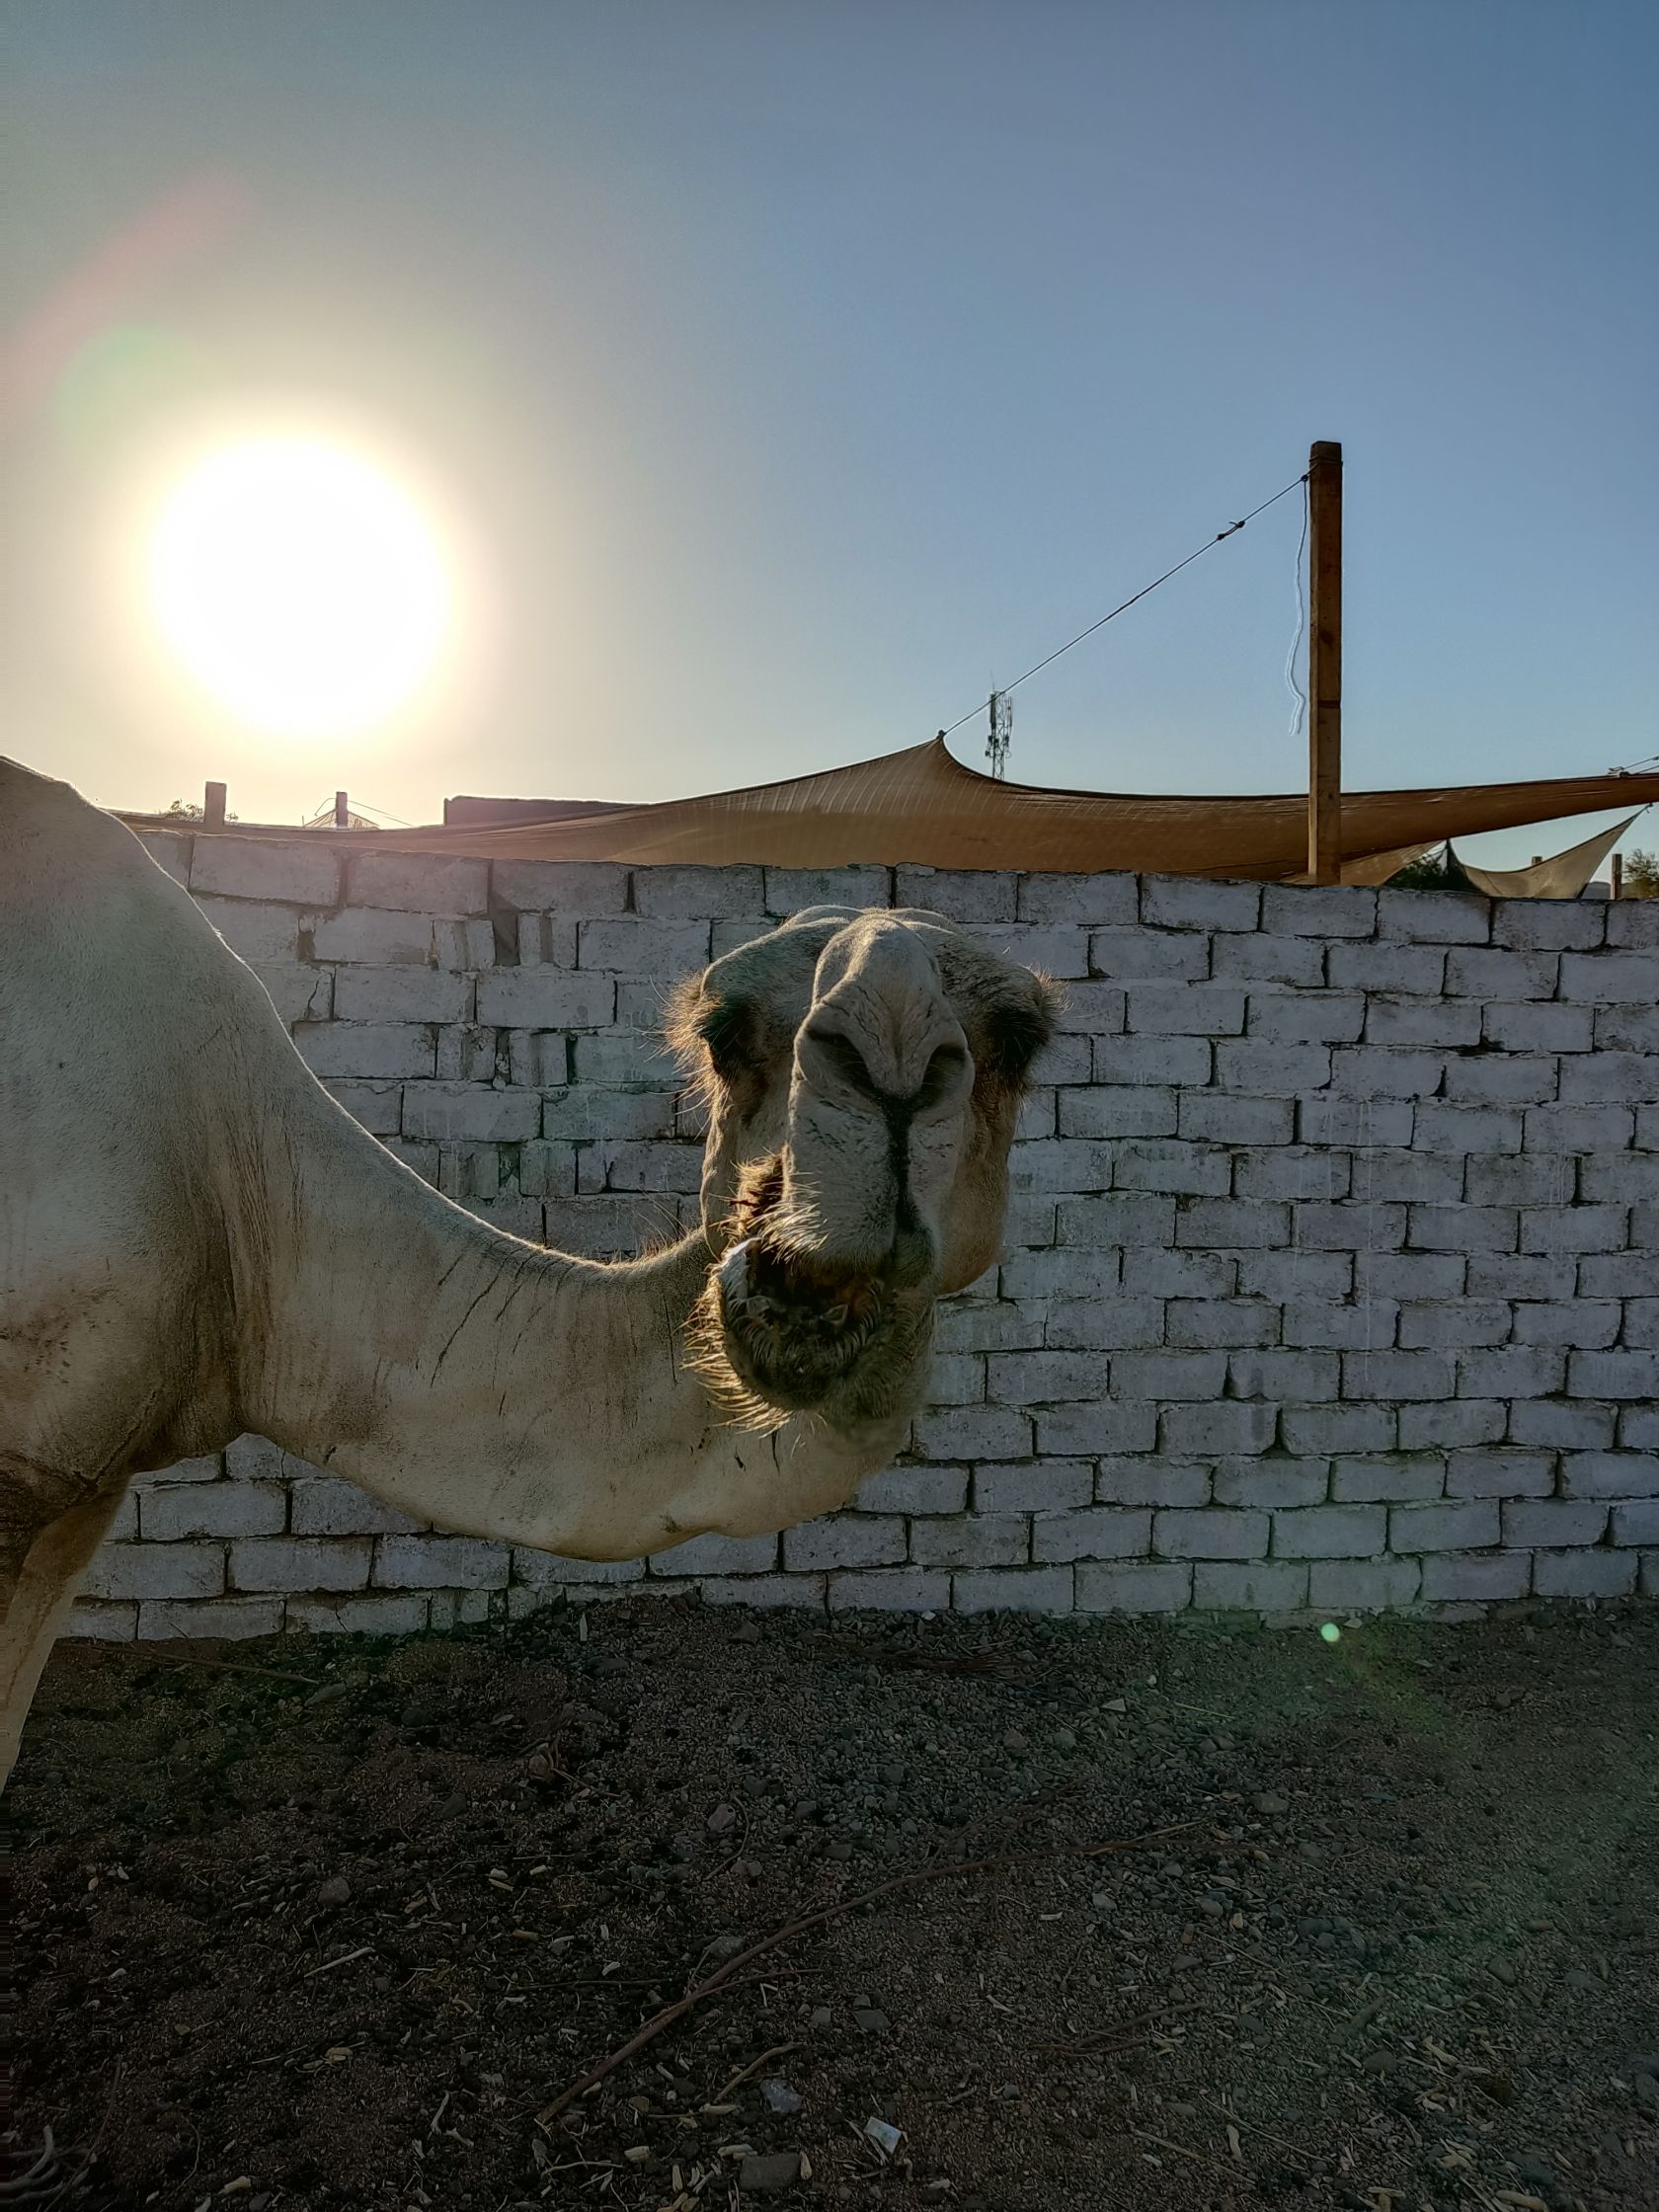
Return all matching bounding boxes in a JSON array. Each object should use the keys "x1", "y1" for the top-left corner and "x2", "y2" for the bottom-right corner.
[{"x1": 0, "y1": 761, "x2": 1051, "y2": 1780}]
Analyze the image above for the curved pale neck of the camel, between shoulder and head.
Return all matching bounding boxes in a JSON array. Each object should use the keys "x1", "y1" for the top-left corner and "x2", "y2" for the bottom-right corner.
[{"x1": 232, "y1": 1095, "x2": 907, "y2": 1559}]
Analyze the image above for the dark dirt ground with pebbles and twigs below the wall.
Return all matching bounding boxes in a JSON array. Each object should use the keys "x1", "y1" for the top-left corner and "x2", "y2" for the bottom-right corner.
[{"x1": 13, "y1": 1600, "x2": 1659, "y2": 2212}]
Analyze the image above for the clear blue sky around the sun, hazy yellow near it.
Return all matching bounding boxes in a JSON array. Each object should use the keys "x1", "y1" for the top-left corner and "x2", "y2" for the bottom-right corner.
[{"x1": 0, "y1": 0, "x2": 1659, "y2": 865}]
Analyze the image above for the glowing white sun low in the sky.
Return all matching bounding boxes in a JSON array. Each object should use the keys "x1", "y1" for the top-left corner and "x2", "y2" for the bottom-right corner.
[{"x1": 148, "y1": 435, "x2": 453, "y2": 737}]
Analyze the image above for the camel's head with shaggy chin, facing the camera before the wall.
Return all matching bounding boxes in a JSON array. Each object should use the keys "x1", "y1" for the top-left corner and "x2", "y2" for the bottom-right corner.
[{"x1": 674, "y1": 907, "x2": 1053, "y2": 1427}]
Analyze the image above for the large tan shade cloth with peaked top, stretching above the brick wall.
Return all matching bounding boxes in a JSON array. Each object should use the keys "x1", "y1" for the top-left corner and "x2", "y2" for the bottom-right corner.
[{"x1": 128, "y1": 739, "x2": 1659, "y2": 881}]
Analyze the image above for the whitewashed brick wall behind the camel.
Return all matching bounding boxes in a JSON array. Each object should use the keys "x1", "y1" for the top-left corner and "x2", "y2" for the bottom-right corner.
[{"x1": 77, "y1": 833, "x2": 1659, "y2": 1637}]
